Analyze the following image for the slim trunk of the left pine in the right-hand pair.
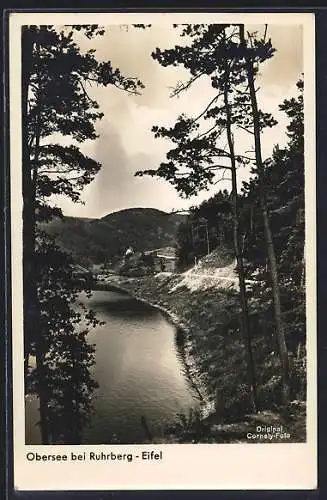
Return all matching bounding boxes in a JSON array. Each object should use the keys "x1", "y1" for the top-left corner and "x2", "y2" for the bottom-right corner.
[{"x1": 224, "y1": 75, "x2": 259, "y2": 412}]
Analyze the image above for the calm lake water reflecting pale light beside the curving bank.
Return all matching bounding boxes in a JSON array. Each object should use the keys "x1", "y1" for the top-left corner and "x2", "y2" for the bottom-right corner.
[{"x1": 26, "y1": 291, "x2": 198, "y2": 444}]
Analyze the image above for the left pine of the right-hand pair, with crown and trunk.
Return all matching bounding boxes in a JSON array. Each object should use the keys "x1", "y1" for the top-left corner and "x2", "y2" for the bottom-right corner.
[{"x1": 138, "y1": 25, "x2": 275, "y2": 410}]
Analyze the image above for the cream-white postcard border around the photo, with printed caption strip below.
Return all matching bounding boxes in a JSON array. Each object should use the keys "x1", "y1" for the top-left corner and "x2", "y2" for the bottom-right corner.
[{"x1": 9, "y1": 12, "x2": 317, "y2": 490}]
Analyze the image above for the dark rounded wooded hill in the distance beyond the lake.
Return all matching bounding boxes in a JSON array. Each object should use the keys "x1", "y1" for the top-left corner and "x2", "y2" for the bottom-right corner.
[{"x1": 43, "y1": 208, "x2": 185, "y2": 265}]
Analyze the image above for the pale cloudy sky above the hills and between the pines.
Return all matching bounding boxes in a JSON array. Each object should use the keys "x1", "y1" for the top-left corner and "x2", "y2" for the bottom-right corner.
[{"x1": 54, "y1": 24, "x2": 303, "y2": 218}]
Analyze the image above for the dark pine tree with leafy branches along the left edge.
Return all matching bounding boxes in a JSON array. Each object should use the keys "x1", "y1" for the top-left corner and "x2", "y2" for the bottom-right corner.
[{"x1": 22, "y1": 25, "x2": 142, "y2": 444}]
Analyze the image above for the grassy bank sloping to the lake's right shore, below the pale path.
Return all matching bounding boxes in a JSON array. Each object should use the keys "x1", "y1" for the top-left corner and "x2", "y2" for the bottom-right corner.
[{"x1": 95, "y1": 252, "x2": 305, "y2": 443}]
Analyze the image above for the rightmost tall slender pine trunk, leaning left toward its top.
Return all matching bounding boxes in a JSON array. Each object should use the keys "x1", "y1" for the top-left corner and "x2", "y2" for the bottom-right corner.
[{"x1": 240, "y1": 25, "x2": 290, "y2": 405}]
